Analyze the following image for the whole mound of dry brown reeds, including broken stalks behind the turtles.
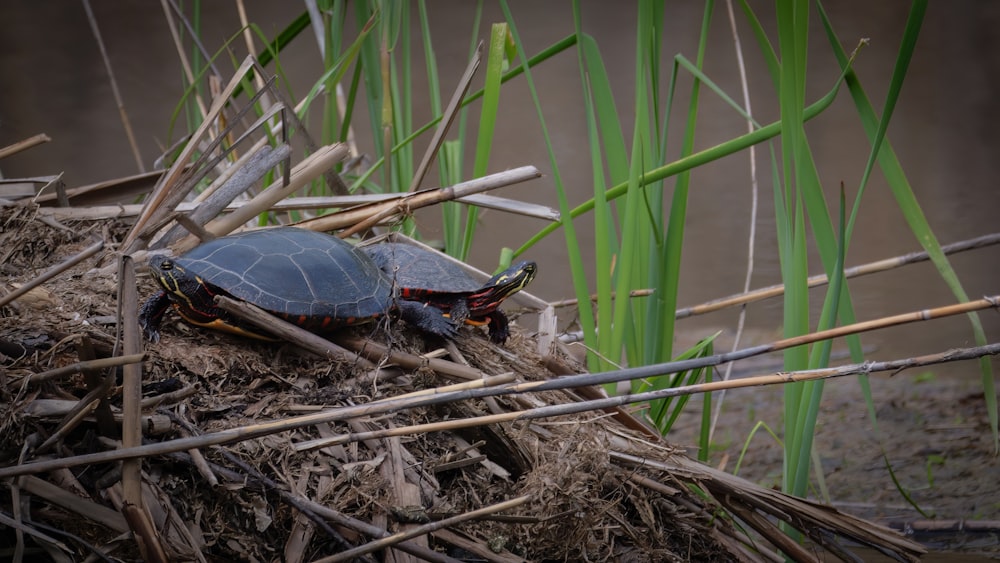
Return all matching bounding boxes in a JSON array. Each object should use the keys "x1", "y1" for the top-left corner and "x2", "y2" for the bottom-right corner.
[{"x1": 0, "y1": 59, "x2": 922, "y2": 562}]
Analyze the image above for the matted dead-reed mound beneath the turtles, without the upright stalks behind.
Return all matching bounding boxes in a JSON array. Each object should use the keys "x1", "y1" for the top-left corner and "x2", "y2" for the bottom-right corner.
[{"x1": 0, "y1": 202, "x2": 919, "y2": 561}]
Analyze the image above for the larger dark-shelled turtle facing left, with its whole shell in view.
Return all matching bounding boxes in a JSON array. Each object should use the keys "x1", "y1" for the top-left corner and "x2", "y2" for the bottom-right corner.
[{"x1": 139, "y1": 227, "x2": 457, "y2": 342}]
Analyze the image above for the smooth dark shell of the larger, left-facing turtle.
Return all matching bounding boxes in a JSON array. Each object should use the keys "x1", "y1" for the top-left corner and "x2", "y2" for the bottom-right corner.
[{"x1": 166, "y1": 227, "x2": 393, "y2": 328}]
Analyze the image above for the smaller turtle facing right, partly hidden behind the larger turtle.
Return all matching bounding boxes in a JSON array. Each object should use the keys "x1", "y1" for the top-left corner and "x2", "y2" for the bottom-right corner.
[{"x1": 361, "y1": 242, "x2": 538, "y2": 344}]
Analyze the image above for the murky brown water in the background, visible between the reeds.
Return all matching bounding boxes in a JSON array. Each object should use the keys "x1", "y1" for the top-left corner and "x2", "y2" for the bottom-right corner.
[{"x1": 0, "y1": 0, "x2": 1000, "y2": 372}]
